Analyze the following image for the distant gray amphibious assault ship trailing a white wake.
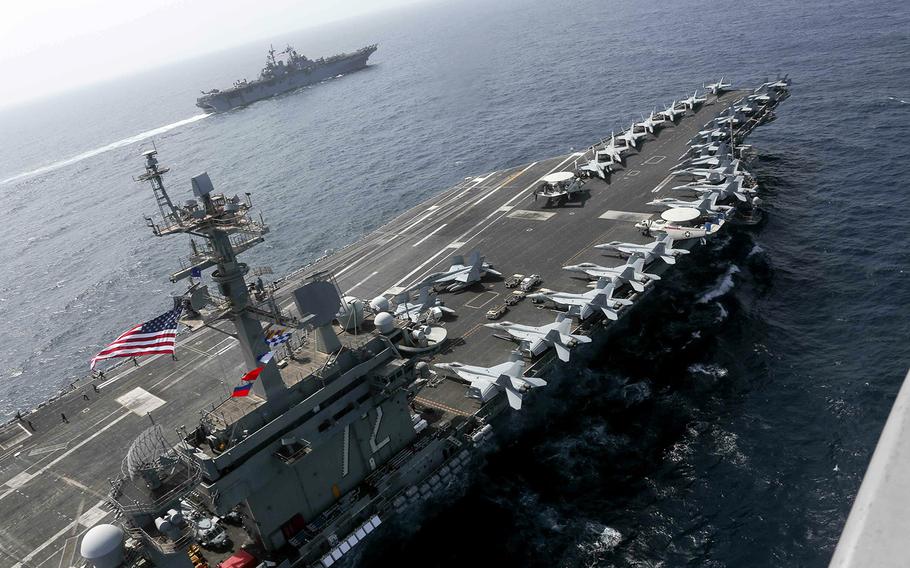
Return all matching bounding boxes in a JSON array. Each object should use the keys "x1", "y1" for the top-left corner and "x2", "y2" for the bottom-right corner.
[{"x1": 196, "y1": 45, "x2": 378, "y2": 112}]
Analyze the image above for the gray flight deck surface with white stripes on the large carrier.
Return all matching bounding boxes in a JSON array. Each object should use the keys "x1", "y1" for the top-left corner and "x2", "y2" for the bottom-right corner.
[{"x1": 0, "y1": 92, "x2": 742, "y2": 568}]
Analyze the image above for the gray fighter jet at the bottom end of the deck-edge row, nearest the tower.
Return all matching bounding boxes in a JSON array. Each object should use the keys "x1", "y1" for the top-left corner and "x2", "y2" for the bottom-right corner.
[{"x1": 434, "y1": 353, "x2": 547, "y2": 410}]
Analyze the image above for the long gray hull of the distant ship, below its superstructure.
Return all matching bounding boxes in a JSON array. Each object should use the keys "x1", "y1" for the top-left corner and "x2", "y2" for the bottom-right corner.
[{"x1": 196, "y1": 51, "x2": 373, "y2": 112}]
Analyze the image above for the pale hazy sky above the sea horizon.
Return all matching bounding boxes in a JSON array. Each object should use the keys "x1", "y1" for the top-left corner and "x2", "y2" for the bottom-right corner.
[{"x1": 0, "y1": 0, "x2": 414, "y2": 107}]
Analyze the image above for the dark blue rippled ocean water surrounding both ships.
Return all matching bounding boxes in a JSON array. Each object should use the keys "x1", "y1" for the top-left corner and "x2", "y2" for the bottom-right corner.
[{"x1": 0, "y1": 0, "x2": 910, "y2": 566}]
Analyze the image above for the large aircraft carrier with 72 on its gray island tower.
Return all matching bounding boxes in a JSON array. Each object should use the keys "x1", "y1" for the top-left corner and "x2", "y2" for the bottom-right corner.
[{"x1": 0, "y1": 79, "x2": 789, "y2": 568}]
